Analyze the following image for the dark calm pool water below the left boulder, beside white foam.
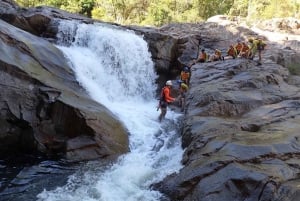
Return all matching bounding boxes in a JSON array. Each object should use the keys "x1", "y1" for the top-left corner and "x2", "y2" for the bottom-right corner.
[{"x1": 0, "y1": 155, "x2": 82, "y2": 201}]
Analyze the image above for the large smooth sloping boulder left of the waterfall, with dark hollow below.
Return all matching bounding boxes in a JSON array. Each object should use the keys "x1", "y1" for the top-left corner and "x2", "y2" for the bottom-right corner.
[{"x1": 0, "y1": 20, "x2": 129, "y2": 161}]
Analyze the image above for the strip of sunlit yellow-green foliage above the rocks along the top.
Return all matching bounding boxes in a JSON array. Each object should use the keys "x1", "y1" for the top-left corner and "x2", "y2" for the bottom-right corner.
[{"x1": 16, "y1": 0, "x2": 300, "y2": 26}]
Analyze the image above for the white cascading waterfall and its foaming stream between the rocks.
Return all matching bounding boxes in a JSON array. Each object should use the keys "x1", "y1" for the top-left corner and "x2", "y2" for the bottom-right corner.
[{"x1": 38, "y1": 22, "x2": 182, "y2": 201}]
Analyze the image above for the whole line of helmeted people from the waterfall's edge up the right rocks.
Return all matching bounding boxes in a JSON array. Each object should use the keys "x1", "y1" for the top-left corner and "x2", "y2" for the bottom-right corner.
[{"x1": 157, "y1": 38, "x2": 266, "y2": 121}]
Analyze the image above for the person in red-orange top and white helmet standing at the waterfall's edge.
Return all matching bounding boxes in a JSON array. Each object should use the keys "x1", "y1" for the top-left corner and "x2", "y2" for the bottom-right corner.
[{"x1": 158, "y1": 80, "x2": 175, "y2": 121}]
